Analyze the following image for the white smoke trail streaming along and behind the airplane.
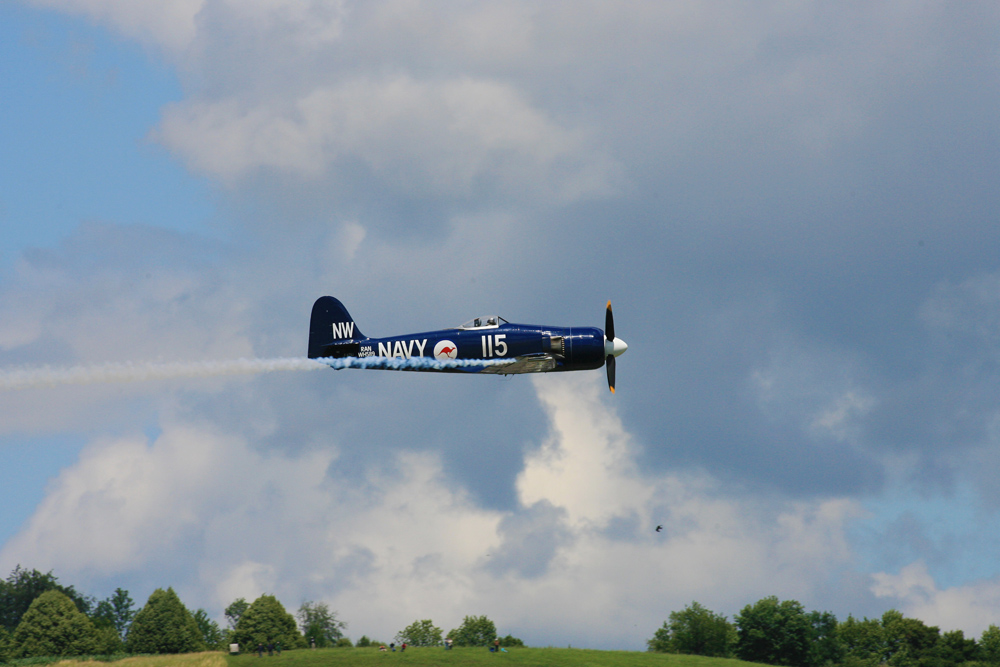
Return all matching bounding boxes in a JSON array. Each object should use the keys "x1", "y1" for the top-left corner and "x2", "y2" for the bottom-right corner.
[{"x1": 0, "y1": 357, "x2": 510, "y2": 391}]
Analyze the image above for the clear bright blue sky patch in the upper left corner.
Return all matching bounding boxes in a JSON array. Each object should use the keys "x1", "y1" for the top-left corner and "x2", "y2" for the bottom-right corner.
[{"x1": 0, "y1": 3, "x2": 214, "y2": 266}]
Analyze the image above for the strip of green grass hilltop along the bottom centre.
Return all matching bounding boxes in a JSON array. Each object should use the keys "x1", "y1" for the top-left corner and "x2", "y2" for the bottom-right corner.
[{"x1": 223, "y1": 647, "x2": 756, "y2": 667}]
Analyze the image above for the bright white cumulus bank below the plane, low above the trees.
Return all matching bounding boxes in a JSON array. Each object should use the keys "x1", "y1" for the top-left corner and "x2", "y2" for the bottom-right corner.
[{"x1": 0, "y1": 377, "x2": 857, "y2": 648}]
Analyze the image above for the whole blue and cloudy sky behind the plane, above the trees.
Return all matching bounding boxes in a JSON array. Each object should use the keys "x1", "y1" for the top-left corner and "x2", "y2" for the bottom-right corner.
[{"x1": 0, "y1": 0, "x2": 1000, "y2": 649}]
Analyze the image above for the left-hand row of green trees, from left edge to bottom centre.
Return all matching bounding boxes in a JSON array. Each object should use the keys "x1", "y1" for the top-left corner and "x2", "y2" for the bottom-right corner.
[{"x1": 0, "y1": 565, "x2": 524, "y2": 663}]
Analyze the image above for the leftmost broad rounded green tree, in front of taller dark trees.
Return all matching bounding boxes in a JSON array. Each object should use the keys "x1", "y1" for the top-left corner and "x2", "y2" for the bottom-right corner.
[{"x1": 11, "y1": 590, "x2": 98, "y2": 658}]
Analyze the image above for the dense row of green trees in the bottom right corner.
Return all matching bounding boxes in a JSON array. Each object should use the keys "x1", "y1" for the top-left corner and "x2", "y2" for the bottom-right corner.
[{"x1": 646, "y1": 596, "x2": 1000, "y2": 667}]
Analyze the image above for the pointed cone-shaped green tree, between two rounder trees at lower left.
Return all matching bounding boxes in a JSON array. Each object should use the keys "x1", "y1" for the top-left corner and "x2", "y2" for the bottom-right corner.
[{"x1": 125, "y1": 588, "x2": 206, "y2": 653}]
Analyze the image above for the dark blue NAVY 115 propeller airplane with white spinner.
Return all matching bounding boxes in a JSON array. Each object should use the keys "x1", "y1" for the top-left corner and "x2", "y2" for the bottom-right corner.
[{"x1": 309, "y1": 296, "x2": 628, "y2": 393}]
